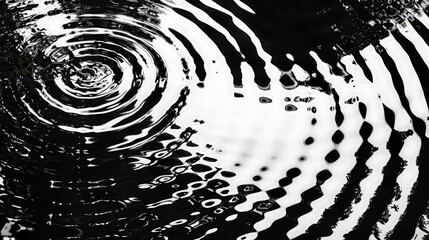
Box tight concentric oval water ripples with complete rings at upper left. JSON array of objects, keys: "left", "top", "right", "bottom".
[{"left": 7, "top": 8, "right": 188, "bottom": 150}]
